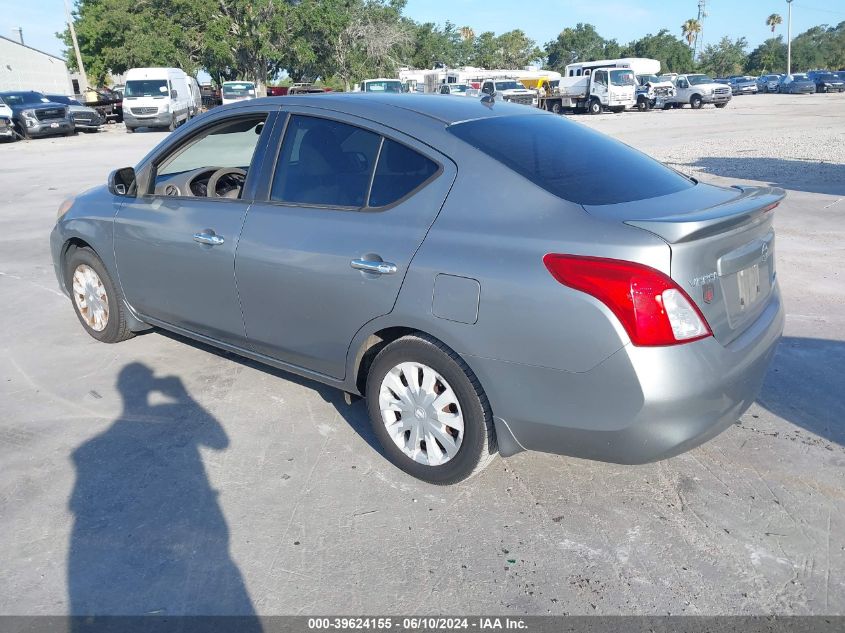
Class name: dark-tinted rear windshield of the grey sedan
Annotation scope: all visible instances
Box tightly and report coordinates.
[448,115,694,205]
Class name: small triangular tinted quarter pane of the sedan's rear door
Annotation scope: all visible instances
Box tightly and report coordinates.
[367,139,438,207]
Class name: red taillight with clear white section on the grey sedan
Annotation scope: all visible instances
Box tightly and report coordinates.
[543,253,711,346]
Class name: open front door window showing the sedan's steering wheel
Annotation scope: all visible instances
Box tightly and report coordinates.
[154,114,267,198]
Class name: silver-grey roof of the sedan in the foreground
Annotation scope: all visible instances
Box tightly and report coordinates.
[249,92,543,125]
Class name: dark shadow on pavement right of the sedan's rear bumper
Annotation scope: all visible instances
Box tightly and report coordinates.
[757,336,845,446]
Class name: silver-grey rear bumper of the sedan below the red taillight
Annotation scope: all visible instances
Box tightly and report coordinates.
[468,286,784,464]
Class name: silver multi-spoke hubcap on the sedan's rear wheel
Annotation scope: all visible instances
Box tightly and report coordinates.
[379,362,464,466]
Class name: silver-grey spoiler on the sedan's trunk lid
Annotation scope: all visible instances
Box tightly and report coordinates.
[625,185,786,244]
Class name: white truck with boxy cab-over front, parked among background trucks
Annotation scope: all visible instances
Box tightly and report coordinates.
[537,68,637,114]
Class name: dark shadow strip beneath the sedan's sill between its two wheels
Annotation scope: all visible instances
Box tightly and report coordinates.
[150,329,384,456]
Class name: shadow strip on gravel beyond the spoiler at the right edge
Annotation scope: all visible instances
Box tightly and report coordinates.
[668,156,845,196]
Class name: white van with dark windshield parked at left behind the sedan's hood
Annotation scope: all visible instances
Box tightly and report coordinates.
[123,68,194,132]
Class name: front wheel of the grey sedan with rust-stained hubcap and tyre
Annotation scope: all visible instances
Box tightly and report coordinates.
[65,248,133,343]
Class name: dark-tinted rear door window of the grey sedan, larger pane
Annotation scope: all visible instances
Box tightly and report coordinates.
[270,115,381,208]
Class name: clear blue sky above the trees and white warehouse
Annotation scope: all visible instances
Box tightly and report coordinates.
[0,0,845,61]
